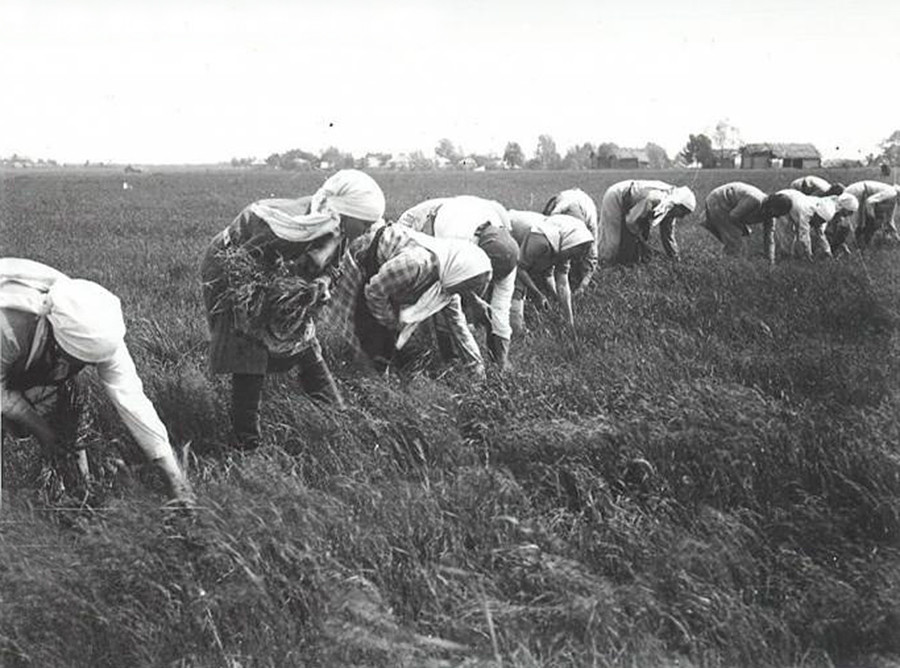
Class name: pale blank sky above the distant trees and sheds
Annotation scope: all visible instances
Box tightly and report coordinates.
[0,0,900,163]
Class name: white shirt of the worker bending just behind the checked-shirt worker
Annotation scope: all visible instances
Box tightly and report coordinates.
[397,195,516,340]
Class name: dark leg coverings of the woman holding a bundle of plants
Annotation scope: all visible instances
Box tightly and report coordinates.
[231,344,344,450]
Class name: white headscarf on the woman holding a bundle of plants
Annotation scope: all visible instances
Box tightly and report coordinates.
[250,169,385,242]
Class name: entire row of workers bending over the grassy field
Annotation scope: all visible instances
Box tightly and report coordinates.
[0,170,898,501]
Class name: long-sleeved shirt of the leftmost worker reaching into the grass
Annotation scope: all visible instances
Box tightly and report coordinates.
[0,308,177,468]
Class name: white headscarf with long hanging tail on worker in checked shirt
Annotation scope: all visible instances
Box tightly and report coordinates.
[396,231,491,350]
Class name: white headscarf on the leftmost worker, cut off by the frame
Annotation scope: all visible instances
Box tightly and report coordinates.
[0,258,125,368]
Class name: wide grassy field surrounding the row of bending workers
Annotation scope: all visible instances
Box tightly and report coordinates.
[0,170,900,667]
